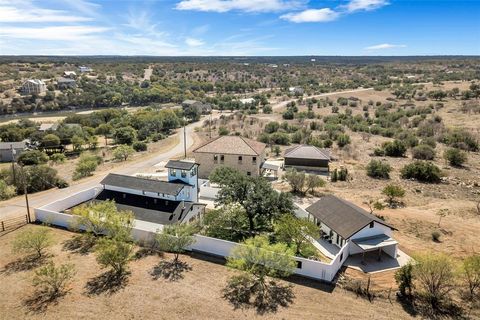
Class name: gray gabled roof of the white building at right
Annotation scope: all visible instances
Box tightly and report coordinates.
[305,195,393,239]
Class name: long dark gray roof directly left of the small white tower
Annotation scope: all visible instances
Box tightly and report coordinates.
[100,173,184,196]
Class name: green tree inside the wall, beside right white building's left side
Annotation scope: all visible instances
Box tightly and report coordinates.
[274,214,319,258]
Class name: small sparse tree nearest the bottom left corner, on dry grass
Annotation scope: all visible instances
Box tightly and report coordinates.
[33,262,76,299]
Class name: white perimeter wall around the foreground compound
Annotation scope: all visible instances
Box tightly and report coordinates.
[35,189,350,282]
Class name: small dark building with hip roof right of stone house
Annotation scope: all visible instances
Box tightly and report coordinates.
[284,145,330,172]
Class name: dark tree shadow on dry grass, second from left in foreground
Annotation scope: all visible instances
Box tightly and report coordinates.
[85,271,130,296]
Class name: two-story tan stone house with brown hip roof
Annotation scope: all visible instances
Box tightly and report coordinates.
[193,136,266,179]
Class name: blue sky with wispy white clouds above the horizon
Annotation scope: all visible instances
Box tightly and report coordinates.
[0,0,480,56]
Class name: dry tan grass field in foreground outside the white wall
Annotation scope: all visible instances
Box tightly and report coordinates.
[0,225,409,319]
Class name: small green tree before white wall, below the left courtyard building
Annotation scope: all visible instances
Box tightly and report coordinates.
[155,223,195,263]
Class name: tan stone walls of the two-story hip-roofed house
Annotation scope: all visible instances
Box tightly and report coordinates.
[194,152,265,179]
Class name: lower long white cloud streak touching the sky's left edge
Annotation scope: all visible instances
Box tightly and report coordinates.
[0,26,108,41]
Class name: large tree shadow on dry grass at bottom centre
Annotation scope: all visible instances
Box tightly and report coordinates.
[223,276,295,315]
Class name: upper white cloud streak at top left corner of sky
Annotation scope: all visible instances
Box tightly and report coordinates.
[0,6,92,23]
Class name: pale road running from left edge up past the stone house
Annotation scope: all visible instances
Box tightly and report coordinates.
[0,114,208,218]
